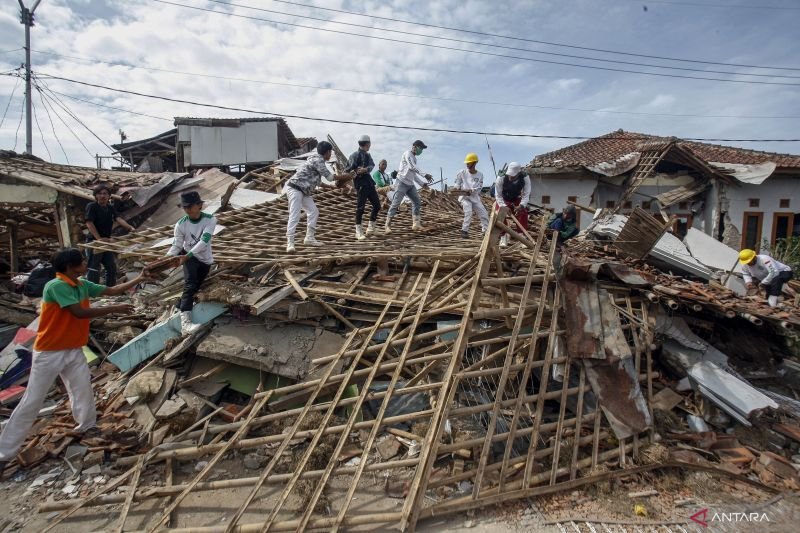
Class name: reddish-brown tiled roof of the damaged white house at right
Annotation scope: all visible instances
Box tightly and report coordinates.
[529,129,800,169]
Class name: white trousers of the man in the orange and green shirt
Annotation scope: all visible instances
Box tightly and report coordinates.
[0,348,97,461]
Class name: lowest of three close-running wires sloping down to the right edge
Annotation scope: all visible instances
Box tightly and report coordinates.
[151,0,800,87]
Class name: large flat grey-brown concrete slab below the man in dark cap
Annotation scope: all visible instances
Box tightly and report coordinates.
[197,319,345,379]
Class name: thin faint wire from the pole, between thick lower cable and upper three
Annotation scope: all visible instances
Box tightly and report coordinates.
[31,50,800,120]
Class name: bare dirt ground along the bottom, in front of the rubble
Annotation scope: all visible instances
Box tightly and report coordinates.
[0,456,800,533]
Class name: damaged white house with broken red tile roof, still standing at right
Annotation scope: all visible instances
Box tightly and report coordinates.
[528,130,800,245]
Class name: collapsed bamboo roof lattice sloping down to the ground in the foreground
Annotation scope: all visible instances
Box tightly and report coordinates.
[40,207,652,533]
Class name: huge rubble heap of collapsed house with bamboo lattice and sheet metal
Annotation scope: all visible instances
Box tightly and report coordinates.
[4,143,800,532]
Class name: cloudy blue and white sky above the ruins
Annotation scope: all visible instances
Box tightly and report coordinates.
[0,0,800,178]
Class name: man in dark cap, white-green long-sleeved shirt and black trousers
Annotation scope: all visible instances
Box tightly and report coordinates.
[167,191,217,335]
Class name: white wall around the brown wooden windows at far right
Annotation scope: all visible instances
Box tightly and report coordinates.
[723,176,800,249]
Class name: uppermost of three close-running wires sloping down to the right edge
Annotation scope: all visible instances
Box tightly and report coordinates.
[255,0,800,71]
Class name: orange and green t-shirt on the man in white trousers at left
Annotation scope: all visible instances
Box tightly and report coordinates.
[33,272,106,352]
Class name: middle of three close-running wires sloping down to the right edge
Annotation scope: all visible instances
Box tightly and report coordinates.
[202,0,800,79]
